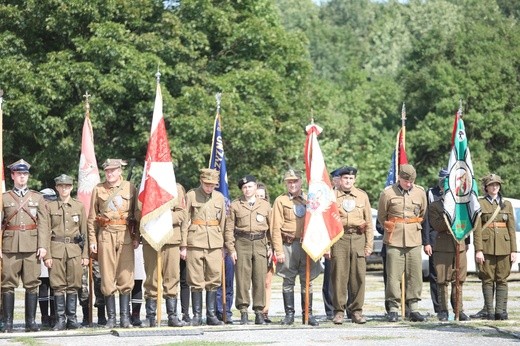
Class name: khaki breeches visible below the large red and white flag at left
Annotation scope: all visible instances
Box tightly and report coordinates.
[143,244,180,300]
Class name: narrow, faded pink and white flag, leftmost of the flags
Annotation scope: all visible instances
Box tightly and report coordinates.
[78,100,100,215]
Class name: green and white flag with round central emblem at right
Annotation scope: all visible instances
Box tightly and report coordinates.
[444,106,480,241]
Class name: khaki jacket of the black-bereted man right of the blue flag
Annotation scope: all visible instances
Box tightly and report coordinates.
[226,196,271,253]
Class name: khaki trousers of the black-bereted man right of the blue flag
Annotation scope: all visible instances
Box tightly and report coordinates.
[235,237,267,312]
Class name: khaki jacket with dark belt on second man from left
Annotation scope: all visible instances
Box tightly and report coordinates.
[45,198,88,260]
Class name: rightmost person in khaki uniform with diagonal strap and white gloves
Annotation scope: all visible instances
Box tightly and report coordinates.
[474,174,517,320]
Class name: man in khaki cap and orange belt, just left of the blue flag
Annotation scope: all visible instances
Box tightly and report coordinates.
[180,168,226,326]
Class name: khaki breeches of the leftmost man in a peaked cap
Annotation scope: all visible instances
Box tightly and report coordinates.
[2,252,41,293]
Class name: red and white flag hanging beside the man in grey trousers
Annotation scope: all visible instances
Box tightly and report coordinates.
[302,124,343,261]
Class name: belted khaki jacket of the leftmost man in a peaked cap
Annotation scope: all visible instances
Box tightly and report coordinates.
[1,190,50,253]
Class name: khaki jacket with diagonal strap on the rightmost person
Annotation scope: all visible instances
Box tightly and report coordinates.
[474,197,517,256]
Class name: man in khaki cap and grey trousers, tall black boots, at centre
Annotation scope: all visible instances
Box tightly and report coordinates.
[270,169,321,326]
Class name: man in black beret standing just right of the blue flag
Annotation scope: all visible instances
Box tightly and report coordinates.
[226,175,271,324]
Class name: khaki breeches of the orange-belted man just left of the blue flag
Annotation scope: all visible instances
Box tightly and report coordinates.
[186,247,223,292]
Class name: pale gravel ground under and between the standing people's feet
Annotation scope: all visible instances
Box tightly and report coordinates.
[0,266,520,346]
